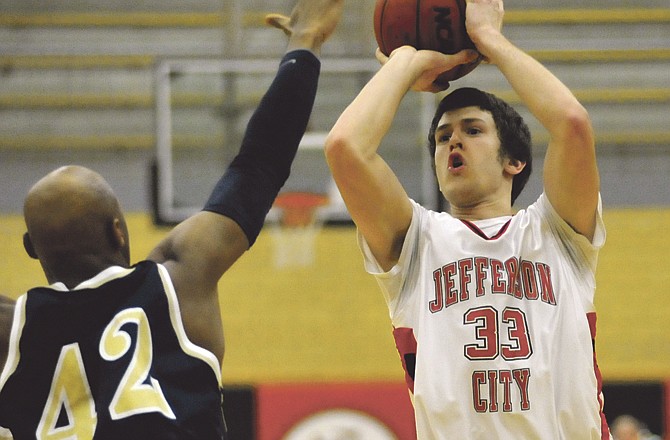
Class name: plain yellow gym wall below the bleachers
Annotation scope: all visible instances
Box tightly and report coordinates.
[0,209,670,384]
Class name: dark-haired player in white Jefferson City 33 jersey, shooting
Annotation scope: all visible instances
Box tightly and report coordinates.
[325,0,609,440]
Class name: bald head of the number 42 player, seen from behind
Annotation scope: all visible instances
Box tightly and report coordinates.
[23,166,129,281]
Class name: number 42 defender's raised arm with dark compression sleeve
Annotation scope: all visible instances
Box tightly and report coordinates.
[149,0,344,355]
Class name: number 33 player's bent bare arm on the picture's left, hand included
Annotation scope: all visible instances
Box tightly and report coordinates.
[325,46,476,269]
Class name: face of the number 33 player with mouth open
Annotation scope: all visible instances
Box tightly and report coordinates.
[435,107,509,207]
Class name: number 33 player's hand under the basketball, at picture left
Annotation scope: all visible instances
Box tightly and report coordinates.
[375,46,479,93]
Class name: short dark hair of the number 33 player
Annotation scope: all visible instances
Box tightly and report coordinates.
[428,87,533,204]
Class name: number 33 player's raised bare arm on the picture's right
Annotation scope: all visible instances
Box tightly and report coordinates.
[466,0,600,239]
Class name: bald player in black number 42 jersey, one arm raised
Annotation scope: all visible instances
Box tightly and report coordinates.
[0,0,343,440]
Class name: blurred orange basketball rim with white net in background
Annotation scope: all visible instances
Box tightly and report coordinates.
[272,192,328,268]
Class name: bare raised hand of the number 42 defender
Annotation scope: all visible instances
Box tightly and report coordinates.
[265,0,344,52]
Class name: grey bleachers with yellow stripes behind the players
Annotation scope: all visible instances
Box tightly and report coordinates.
[0,0,670,212]
